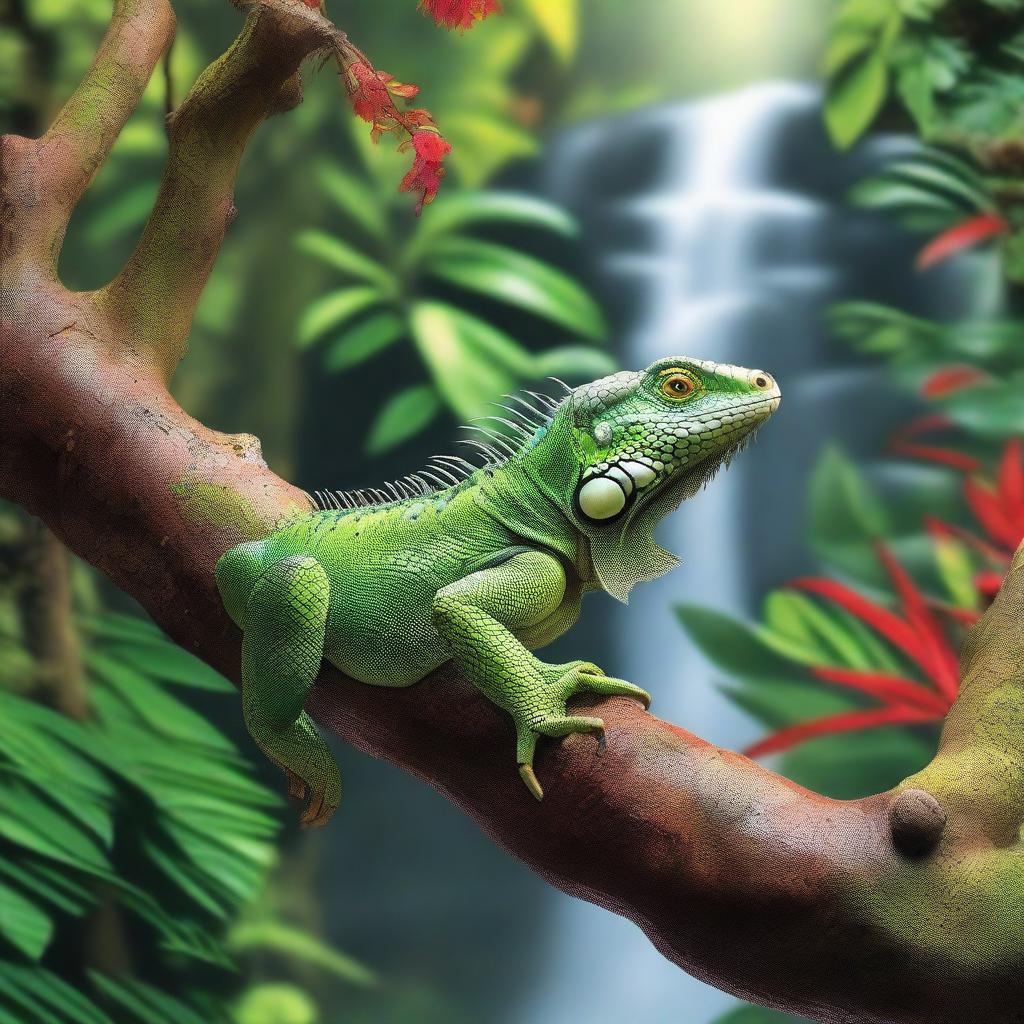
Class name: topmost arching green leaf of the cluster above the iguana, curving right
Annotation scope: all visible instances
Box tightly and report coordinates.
[404,190,580,261]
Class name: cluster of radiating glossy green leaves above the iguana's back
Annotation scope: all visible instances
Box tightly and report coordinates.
[296,173,613,454]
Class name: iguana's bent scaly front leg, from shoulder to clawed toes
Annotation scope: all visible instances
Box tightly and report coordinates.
[433,551,650,800]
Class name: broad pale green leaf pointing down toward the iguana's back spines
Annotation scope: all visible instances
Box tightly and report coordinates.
[410,302,530,420]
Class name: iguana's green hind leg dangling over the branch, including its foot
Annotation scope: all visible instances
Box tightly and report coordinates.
[242,556,341,825]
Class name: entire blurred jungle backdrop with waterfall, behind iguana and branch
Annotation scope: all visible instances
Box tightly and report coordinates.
[0,0,1024,1024]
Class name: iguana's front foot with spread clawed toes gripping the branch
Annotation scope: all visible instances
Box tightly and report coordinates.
[514,662,650,800]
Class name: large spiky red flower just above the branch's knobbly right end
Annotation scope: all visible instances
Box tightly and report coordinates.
[744,545,959,757]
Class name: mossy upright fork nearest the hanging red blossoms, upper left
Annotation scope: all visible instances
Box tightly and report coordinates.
[100,0,340,378]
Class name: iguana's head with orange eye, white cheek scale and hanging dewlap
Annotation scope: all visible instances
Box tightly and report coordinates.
[520,356,781,600]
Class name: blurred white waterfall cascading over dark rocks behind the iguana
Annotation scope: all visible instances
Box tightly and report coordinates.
[520,83,983,1024]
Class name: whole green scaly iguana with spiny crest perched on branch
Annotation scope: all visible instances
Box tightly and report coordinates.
[217,357,780,824]
